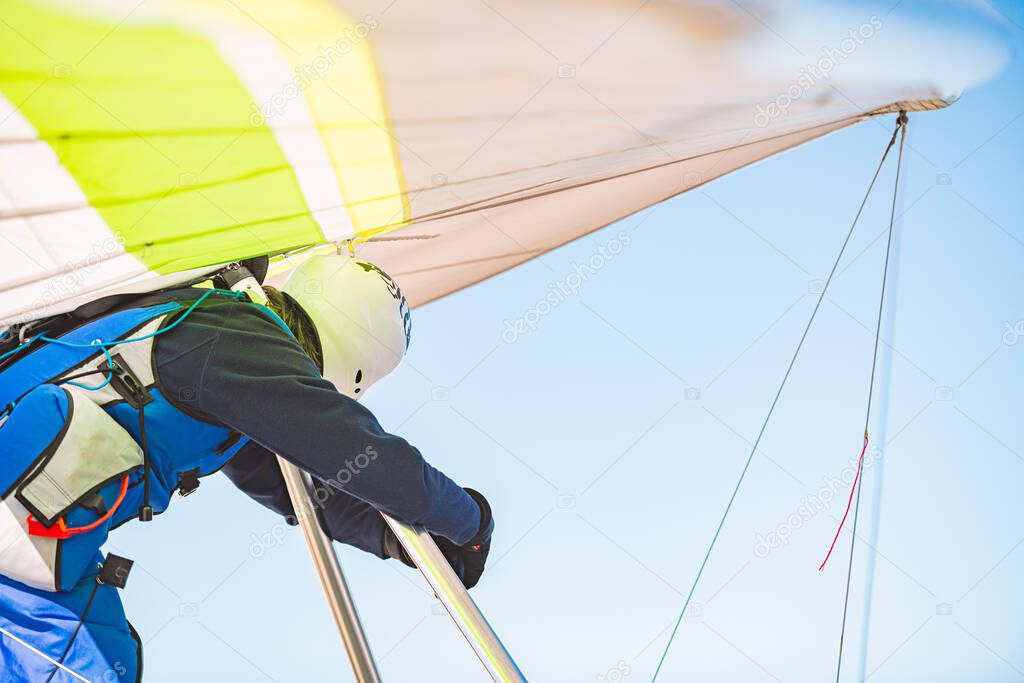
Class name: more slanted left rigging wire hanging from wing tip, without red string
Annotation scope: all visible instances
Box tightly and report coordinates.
[650,113,905,683]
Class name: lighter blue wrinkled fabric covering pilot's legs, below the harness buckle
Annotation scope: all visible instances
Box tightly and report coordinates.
[0,553,142,683]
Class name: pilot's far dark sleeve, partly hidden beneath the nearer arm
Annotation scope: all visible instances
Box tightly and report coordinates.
[221,442,389,557]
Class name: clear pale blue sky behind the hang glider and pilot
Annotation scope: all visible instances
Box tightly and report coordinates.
[110,2,1024,683]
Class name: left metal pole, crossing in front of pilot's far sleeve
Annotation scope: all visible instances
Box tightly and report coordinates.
[278,456,381,683]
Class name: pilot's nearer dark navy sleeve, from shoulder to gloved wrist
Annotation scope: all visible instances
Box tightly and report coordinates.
[155,302,480,544]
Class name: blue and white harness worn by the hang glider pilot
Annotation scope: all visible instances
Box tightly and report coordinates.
[0,290,270,683]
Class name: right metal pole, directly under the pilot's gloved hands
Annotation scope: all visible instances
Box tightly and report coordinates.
[384,515,526,683]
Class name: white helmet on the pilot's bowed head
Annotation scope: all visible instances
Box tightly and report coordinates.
[282,254,412,398]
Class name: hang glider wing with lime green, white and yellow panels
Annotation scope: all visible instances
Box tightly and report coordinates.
[0,0,995,323]
